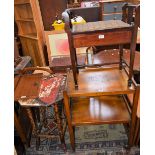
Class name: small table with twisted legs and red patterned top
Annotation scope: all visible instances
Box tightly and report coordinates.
[15,74,66,151]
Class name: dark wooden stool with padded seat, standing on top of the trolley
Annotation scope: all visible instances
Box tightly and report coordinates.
[64,18,137,86]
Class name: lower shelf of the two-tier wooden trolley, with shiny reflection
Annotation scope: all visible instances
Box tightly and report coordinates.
[71,96,130,126]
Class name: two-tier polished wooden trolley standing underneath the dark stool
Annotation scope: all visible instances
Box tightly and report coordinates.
[64,67,139,150]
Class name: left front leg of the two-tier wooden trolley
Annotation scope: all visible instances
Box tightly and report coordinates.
[64,91,75,151]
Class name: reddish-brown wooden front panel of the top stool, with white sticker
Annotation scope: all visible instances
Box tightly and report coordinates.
[73,30,132,48]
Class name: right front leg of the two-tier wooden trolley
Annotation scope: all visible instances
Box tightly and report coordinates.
[129,86,140,146]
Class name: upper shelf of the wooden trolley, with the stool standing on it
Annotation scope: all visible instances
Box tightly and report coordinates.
[67,68,135,97]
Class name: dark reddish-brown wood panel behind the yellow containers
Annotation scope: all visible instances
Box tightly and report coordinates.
[39,0,67,31]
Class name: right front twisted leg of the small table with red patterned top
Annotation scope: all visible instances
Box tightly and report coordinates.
[54,103,66,152]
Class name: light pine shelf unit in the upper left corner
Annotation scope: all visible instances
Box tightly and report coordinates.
[14,0,46,66]
